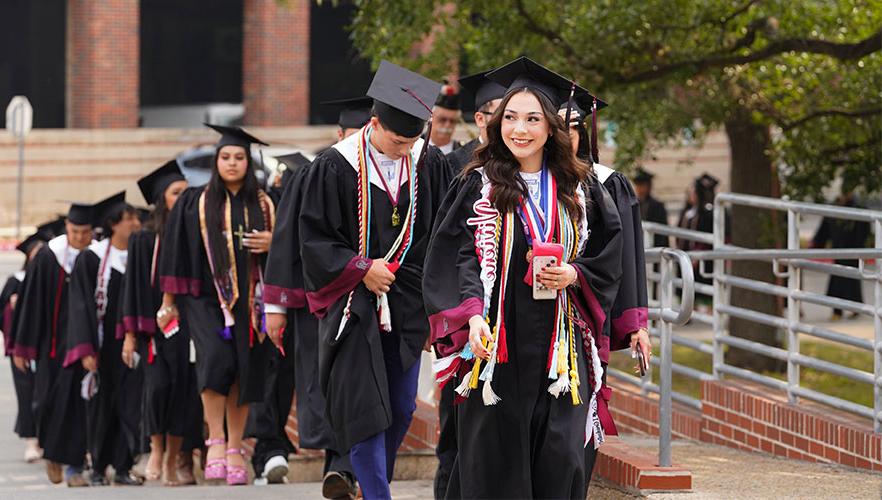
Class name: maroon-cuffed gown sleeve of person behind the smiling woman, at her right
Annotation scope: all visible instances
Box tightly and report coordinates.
[603,172,648,350]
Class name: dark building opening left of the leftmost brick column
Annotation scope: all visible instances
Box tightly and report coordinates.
[0,0,67,128]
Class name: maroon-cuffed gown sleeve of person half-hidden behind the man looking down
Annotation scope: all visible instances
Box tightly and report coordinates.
[263,165,309,309]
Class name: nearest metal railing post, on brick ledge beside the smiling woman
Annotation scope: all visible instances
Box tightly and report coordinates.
[658,252,674,467]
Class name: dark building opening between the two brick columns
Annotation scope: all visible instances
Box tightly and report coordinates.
[141,0,242,106]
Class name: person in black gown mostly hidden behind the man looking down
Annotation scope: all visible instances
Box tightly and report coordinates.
[249,97,373,492]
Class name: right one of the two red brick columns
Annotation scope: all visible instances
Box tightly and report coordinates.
[242,0,310,126]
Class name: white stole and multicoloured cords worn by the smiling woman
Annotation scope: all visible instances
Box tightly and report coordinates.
[454,168,582,405]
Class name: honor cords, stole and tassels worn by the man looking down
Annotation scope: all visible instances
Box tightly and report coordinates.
[335,126,425,340]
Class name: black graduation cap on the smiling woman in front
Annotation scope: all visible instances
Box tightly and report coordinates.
[486,56,588,108]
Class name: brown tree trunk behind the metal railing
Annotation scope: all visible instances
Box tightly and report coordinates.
[726,110,781,371]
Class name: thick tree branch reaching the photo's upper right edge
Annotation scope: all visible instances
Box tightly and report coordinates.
[613,29,882,84]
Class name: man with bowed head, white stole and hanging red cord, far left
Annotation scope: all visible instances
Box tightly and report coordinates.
[12,203,93,486]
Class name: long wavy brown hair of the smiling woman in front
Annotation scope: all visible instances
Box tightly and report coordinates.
[462,88,591,220]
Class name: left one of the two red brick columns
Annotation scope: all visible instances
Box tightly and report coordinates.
[67,0,141,128]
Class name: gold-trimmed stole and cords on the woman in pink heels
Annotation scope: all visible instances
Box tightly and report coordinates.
[199,186,275,346]
